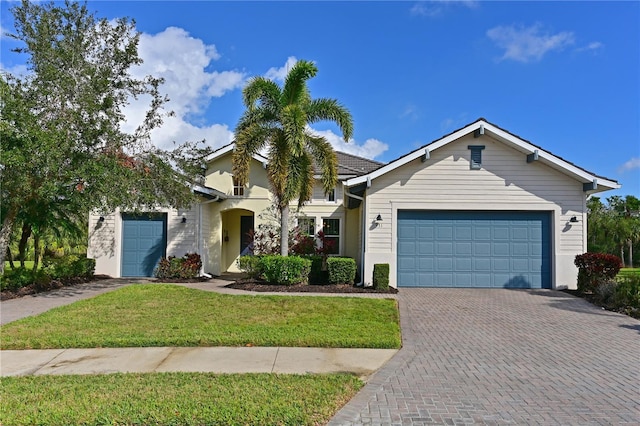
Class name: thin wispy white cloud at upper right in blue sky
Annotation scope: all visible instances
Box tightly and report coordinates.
[487,24,574,63]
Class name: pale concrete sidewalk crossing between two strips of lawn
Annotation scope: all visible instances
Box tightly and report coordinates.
[0,347,398,380]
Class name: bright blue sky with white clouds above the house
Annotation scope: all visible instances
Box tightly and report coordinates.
[0,1,640,197]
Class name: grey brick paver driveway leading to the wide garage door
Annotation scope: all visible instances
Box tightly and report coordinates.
[330,289,640,425]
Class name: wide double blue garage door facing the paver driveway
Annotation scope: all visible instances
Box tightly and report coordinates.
[398,210,551,288]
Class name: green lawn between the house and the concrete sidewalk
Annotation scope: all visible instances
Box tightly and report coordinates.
[0,284,400,349]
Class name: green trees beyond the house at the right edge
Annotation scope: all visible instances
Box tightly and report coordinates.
[587,195,640,268]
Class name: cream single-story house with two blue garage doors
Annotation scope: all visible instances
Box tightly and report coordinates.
[89,118,620,288]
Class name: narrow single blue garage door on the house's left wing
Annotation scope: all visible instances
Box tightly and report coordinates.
[122,213,167,277]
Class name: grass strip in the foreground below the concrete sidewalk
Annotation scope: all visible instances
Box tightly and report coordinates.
[0,373,363,425]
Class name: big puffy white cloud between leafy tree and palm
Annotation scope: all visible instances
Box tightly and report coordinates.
[123,27,246,148]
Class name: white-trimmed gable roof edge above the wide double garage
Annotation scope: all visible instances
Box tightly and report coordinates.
[345,118,620,193]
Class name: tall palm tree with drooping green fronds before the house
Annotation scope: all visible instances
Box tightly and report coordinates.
[233,60,353,256]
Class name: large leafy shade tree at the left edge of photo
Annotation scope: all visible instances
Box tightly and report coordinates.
[0,1,209,273]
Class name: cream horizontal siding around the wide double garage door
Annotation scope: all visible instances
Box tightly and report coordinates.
[366,135,585,285]
